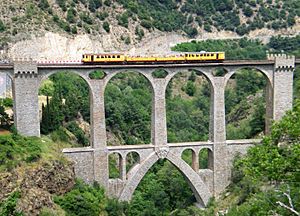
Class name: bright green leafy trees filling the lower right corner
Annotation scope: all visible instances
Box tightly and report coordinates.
[204,100,300,216]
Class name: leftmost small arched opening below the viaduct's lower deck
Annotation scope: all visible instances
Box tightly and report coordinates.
[108,152,123,179]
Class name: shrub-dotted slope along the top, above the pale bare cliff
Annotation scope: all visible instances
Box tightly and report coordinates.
[0,0,300,47]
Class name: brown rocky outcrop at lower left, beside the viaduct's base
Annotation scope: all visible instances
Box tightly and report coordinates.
[0,161,75,216]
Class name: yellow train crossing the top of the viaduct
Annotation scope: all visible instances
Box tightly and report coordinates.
[82,52,225,64]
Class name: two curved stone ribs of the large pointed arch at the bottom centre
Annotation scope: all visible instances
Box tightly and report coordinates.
[119,152,212,207]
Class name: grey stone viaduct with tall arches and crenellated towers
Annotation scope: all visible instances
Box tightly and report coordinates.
[0,54,295,206]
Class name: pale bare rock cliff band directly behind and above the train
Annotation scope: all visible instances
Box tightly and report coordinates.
[8,19,300,61]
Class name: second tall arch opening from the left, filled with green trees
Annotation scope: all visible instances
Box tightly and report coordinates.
[103,69,154,145]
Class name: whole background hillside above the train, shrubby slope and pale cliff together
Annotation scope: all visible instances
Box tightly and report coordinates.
[0,0,300,59]
